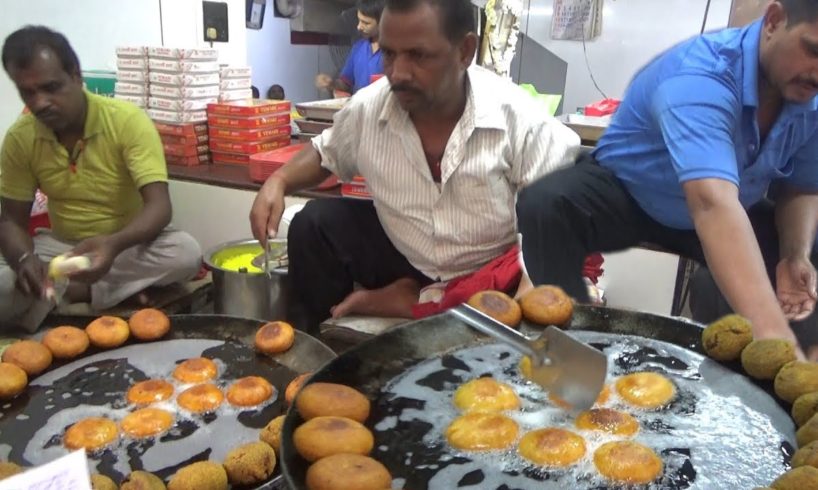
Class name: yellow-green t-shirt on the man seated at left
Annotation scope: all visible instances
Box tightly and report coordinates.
[0,92,168,241]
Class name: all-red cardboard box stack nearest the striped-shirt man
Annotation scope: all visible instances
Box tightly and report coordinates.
[207,99,292,165]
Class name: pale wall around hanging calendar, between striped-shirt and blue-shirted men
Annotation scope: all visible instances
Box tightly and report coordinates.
[521,0,731,112]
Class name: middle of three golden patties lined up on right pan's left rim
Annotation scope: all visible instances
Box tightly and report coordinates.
[293,417,375,461]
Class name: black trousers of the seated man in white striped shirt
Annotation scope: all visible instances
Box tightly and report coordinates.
[287,199,431,332]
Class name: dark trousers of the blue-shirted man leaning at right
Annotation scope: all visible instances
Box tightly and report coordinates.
[517,154,816,345]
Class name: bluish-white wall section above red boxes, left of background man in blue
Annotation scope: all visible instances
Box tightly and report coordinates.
[247,5,335,102]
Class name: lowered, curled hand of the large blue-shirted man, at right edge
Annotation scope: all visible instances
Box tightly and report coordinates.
[775,258,818,320]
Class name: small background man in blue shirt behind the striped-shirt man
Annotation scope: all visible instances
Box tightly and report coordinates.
[316,0,383,94]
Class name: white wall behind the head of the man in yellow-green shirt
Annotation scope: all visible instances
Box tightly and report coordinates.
[0,0,247,139]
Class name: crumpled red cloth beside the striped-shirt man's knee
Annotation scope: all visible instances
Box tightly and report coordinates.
[412,245,603,318]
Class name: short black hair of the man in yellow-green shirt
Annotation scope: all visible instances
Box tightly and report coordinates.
[3,26,81,75]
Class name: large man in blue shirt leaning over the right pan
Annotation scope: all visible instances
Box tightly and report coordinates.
[517,0,818,358]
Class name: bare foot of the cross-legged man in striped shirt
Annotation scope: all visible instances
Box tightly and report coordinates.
[330,278,420,318]
